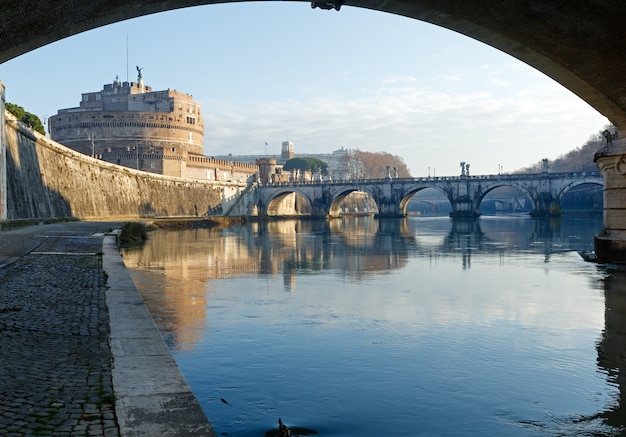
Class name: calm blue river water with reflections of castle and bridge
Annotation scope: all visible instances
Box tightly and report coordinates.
[118,216,626,437]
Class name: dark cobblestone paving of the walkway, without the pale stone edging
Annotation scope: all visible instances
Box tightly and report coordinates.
[0,229,119,437]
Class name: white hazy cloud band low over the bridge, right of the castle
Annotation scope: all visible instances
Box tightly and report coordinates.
[205,78,602,175]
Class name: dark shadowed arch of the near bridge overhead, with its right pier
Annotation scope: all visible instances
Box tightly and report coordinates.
[0,0,626,263]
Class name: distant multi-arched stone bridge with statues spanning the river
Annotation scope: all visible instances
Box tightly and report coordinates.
[251,172,603,217]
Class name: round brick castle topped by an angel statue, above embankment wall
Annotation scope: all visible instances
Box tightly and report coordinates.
[48,76,258,181]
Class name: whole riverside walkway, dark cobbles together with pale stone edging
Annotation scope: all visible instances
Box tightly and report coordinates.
[0,222,215,437]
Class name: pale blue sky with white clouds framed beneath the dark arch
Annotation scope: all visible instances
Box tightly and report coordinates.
[0,1,609,176]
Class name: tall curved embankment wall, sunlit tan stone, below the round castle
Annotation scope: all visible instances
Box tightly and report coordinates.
[0,111,233,220]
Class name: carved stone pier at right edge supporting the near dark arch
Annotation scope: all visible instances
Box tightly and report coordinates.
[594,138,626,263]
